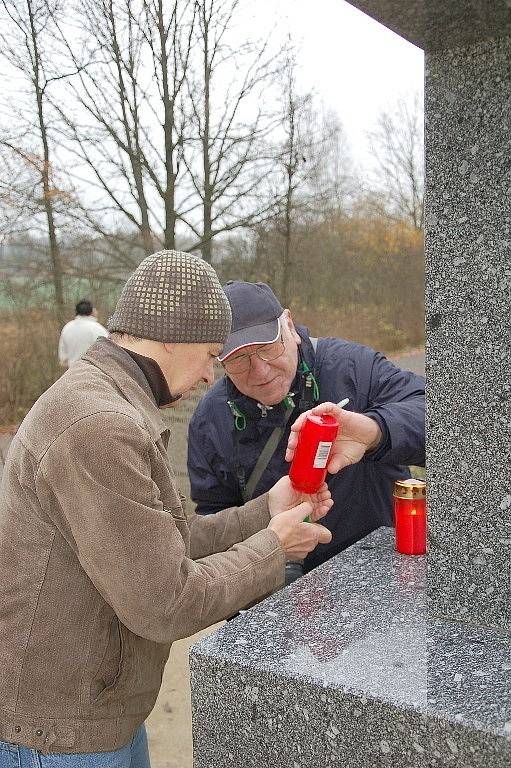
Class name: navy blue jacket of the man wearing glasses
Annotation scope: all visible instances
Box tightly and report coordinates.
[188,327,424,570]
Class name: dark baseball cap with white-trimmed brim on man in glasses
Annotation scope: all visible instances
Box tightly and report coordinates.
[218,280,284,362]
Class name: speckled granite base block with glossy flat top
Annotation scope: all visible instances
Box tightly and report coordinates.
[191,528,511,768]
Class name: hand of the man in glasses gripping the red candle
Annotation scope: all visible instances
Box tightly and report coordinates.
[286,403,382,475]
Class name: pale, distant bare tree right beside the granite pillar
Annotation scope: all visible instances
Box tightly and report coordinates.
[369,95,424,229]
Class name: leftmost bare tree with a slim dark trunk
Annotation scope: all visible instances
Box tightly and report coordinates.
[0,0,74,323]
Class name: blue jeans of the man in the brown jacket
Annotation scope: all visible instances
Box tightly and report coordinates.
[0,725,151,768]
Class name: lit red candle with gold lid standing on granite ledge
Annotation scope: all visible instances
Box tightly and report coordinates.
[394,478,426,555]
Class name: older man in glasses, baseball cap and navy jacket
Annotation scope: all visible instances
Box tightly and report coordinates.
[188,281,425,582]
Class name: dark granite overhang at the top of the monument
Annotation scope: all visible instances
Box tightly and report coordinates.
[348,0,511,50]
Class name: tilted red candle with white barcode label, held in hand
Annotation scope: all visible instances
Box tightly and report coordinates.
[289,413,339,493]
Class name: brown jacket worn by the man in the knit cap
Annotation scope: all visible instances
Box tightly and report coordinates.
[0,339,285,753]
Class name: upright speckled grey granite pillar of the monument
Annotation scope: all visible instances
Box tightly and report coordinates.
[426,37,511,630]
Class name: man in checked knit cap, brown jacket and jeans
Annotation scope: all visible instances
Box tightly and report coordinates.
[0,251,331,768]
